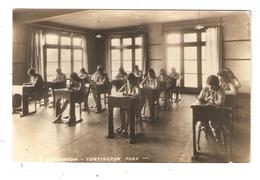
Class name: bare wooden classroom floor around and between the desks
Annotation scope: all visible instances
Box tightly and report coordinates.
[13,95,250,163]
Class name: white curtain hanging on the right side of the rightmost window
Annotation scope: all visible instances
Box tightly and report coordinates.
[206,26,222,76]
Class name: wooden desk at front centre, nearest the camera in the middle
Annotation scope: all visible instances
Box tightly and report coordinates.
[107,95,139,144]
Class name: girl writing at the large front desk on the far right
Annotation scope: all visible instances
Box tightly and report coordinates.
[197,75,225,141]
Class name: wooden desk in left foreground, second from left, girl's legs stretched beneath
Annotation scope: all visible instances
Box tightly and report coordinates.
[54,88,83,126]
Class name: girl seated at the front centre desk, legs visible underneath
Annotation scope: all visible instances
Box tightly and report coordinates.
[116,73,144,136]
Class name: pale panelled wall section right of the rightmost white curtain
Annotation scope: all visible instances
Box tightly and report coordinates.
[222,14,251,93]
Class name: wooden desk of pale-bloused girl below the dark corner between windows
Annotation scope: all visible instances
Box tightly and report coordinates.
[90,83,111,112]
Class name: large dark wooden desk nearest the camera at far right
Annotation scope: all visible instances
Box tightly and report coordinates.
[191,104,232,159]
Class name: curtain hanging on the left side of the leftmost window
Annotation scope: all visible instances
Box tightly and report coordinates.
[27,28,44,77]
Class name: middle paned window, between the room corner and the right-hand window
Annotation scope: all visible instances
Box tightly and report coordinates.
[110,35,144,78]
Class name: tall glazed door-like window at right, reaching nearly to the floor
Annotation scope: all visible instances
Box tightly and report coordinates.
[166,29,206,89]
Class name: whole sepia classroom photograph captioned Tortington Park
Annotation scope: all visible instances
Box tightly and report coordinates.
[12,8,251,163]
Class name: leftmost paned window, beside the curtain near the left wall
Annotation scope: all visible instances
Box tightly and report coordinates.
[44,33,83,81]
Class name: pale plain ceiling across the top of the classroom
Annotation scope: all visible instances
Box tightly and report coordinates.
[13,9,247,30]
